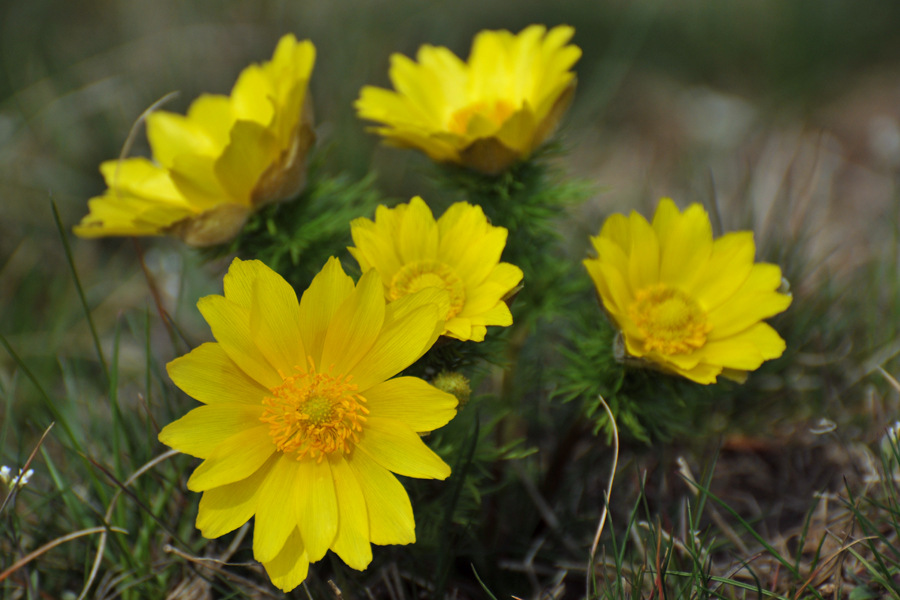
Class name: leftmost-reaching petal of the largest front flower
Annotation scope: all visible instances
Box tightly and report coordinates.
[159,402,263,458]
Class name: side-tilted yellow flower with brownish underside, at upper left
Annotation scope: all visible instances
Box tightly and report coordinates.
[75,34,316,246]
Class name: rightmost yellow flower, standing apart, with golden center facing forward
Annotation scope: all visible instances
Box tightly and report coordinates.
[584,198,791,383]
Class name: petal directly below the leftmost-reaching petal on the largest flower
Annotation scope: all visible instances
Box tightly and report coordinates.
[188,425,275,492]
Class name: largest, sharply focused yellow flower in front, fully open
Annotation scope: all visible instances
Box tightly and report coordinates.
[159,258,457,591]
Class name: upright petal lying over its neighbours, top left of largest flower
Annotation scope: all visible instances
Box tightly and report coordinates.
[250,261,308,376]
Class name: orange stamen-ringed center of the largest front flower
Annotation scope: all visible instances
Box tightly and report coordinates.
[259,359,369,462]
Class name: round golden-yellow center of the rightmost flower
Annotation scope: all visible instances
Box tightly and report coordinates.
[628,283,712,355]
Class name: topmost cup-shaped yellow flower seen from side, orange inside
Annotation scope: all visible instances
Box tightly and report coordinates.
[356,25,581,174]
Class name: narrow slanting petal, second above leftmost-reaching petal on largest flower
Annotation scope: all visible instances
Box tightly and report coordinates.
[197,296,282,389]
